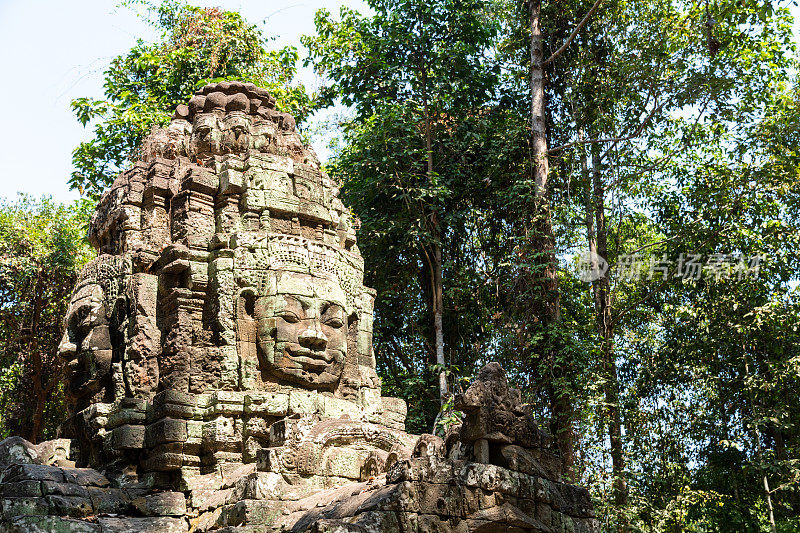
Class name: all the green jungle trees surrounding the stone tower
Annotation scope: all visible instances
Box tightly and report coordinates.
[0,0,800,532]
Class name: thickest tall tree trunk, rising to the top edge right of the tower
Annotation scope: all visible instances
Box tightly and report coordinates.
[528,0,575,477]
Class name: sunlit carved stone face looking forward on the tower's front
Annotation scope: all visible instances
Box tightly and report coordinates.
[255,273,347,389]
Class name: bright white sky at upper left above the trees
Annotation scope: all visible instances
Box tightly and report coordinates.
[0,0,367,201]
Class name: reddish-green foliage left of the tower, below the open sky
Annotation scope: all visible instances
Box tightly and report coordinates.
[0,196,93,442]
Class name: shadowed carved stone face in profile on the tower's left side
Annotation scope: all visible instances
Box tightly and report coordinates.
[58,283,112,400]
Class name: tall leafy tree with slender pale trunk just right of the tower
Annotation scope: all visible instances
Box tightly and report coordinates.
[303,0,495,412]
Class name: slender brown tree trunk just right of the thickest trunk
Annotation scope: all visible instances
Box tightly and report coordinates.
[592,145,628,505]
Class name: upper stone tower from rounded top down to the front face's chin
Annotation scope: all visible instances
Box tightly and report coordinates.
[70,82,379,407]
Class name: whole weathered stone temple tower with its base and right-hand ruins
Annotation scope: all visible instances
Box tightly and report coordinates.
[0,82,596,532]
